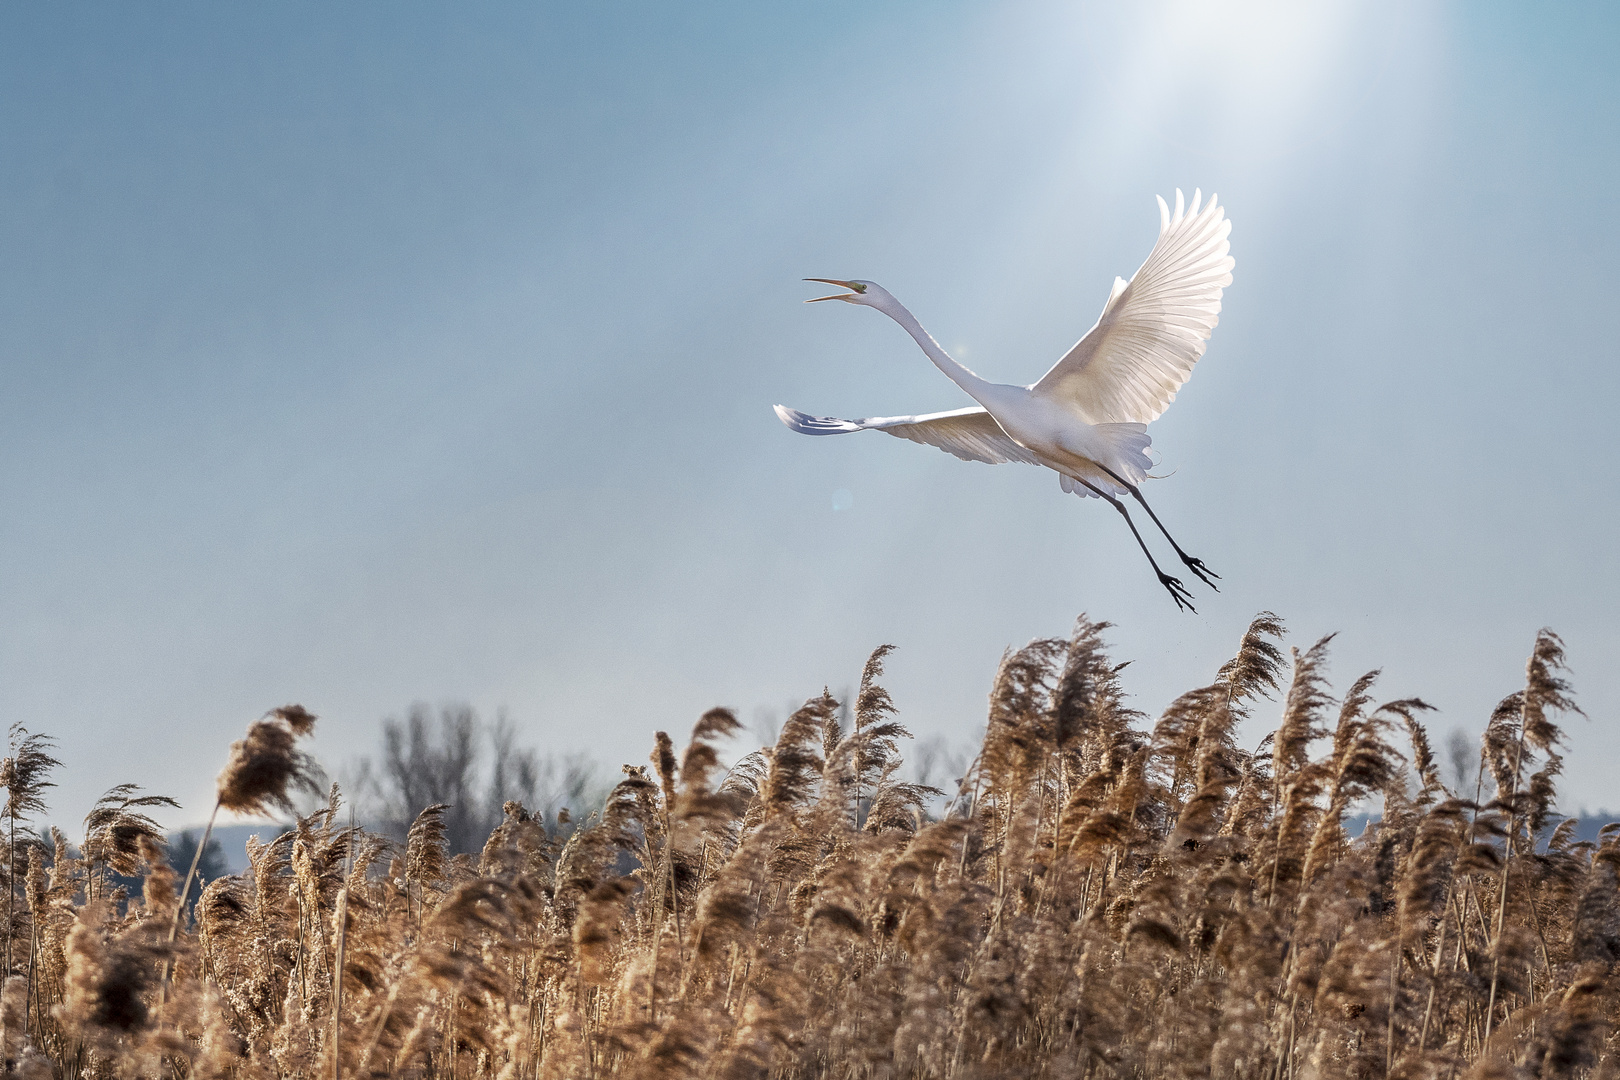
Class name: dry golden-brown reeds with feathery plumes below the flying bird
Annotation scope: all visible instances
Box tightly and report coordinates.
[0,615,1620,1080]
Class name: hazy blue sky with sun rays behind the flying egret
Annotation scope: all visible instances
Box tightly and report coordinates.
[0,0,1620,824]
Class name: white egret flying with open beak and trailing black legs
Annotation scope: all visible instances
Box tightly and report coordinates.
[776,189,1233,610]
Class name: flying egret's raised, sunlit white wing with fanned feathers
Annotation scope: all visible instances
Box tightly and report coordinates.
[1030,189,1233,424]
